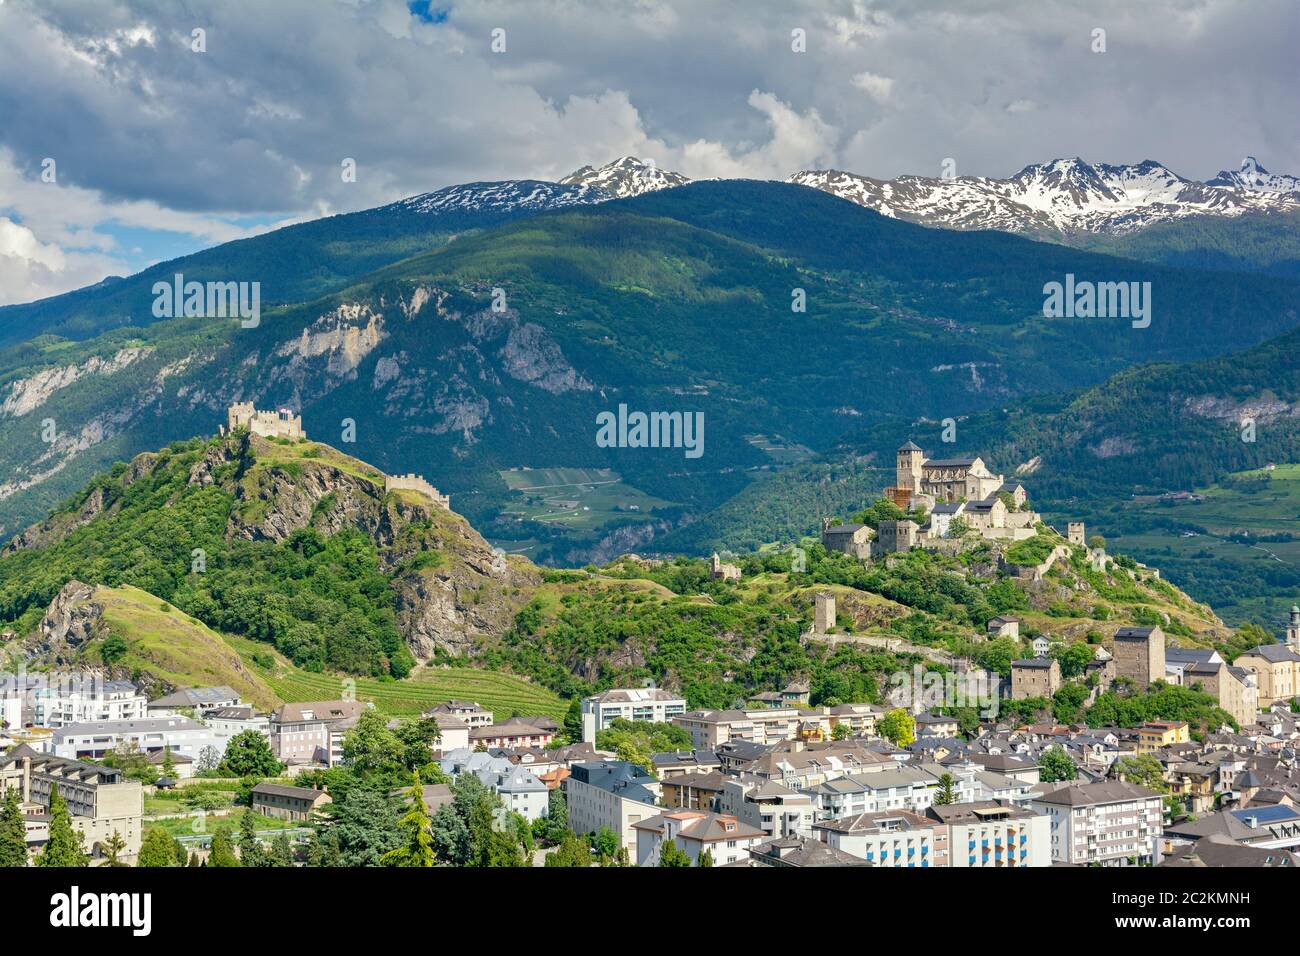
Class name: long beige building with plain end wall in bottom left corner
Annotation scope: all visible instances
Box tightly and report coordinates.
[0,744,144,864]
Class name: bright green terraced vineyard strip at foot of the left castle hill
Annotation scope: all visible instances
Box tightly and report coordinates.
[226,636,567,721]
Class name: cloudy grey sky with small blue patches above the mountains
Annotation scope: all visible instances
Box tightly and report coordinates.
[0,0,1300,304]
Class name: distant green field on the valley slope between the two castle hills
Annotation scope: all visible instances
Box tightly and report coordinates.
[498,468,673,541]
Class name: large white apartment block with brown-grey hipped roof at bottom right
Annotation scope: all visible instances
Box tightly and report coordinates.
[1031,780,1165,866]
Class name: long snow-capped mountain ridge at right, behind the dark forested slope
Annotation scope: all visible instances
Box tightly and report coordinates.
[789,157,1300,234]
